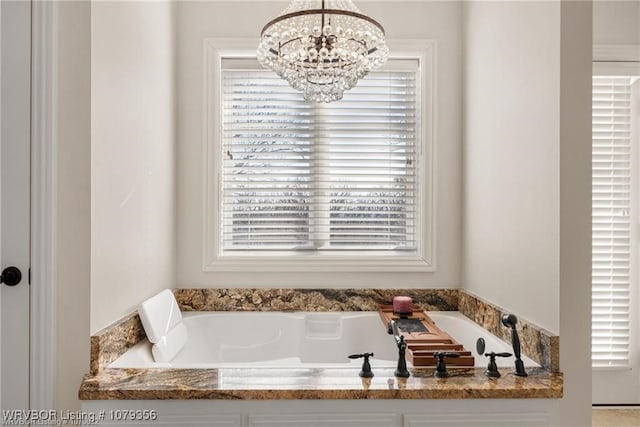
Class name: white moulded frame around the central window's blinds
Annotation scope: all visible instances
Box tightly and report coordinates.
[202,38,436,272]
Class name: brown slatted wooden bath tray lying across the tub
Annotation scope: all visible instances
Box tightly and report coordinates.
[378,305,475,366]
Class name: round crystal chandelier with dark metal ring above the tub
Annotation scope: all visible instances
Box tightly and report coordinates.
[257,0,389,102]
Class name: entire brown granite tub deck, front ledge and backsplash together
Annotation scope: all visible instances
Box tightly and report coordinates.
[79,289,563,401]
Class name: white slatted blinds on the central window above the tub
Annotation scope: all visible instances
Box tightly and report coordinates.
[220,60,419,253]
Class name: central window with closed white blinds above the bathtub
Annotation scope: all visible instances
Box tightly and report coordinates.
[205,41,433,271]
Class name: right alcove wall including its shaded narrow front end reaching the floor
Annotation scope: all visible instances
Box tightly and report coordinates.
[463,1,592,426]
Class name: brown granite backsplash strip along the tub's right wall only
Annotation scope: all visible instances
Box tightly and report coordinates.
[458,291,560,372]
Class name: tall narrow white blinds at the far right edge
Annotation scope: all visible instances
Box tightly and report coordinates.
[591,77,631,367]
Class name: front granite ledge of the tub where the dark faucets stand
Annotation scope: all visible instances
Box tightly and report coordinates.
[79,366,562,400]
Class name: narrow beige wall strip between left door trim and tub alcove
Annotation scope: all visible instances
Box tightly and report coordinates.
[55,2,91,410]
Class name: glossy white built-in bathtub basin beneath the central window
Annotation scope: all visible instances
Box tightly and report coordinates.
[109,312,538,369]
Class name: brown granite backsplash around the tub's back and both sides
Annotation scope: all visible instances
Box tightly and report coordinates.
[90,288,559,375]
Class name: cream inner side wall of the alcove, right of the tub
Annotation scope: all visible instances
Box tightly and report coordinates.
[464,2,560,332]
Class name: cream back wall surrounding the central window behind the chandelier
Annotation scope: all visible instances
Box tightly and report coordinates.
[177,1,462,287]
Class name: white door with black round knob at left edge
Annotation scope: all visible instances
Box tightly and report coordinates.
[0,0,31,411]
